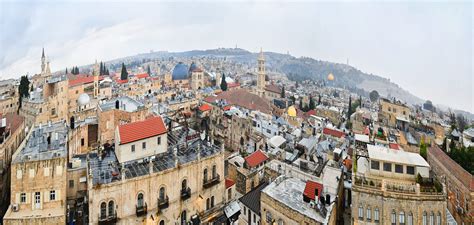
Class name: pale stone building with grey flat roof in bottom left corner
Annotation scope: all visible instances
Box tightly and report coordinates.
[3,121,67,225]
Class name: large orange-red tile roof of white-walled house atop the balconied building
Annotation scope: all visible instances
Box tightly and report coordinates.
[119,116,167,144]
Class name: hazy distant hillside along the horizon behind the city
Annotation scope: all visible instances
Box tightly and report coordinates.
[111,48,423,104]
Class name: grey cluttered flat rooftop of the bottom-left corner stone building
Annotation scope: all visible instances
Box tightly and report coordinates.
[13,121,68,163]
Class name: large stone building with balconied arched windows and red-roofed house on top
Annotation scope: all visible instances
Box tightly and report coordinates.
[88,118,226,224]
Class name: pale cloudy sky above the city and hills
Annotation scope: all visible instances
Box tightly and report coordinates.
[0,0,474,113]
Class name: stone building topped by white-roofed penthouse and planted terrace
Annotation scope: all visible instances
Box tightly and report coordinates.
[351,145,446,225]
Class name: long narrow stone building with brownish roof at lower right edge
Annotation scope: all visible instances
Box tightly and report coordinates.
[428,145,474,224]
